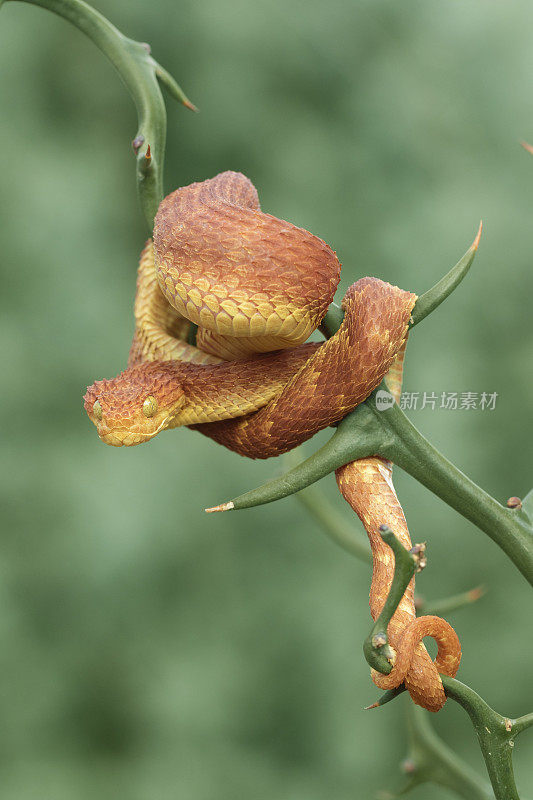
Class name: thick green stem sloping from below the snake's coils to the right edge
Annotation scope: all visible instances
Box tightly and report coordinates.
[374,398,533,585]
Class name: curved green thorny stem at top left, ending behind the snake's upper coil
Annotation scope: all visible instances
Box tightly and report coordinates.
[4,0,194,230]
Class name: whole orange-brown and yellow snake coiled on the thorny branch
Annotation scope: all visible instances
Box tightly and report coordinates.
[84,171,461,711]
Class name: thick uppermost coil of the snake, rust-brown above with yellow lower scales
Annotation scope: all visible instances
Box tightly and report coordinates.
[154,172,340,354]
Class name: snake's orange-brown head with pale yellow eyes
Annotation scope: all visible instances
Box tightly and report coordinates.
[83,361,185,447]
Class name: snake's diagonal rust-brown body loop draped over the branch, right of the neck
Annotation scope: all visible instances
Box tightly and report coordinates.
[191,278,416,458]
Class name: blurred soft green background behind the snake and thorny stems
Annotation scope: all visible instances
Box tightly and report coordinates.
[0,0,533,800]
